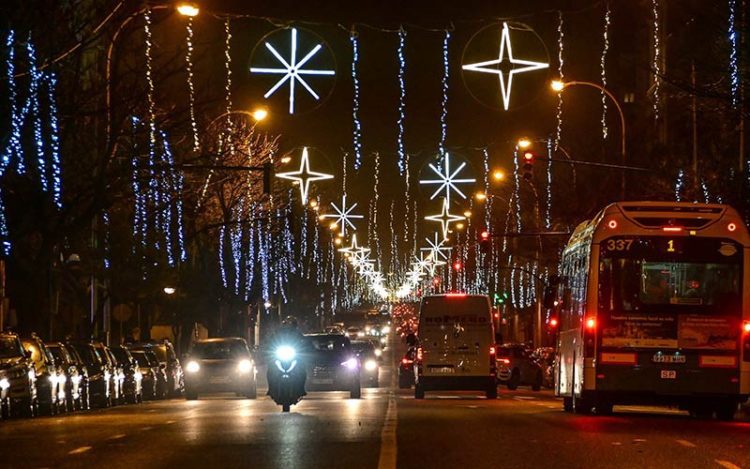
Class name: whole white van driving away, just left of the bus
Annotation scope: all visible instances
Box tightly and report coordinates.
[414,293,497,399]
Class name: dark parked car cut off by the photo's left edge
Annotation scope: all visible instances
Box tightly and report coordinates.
[0,333,37,418]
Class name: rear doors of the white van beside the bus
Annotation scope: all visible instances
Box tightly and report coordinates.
[419,295,493,377]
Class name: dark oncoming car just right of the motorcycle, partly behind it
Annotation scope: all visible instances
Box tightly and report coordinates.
[305,334,361,399]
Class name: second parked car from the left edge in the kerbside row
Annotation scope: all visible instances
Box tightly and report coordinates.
[21,334,67,415]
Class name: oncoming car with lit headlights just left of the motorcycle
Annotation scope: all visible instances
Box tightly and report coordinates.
[185,337,258,400]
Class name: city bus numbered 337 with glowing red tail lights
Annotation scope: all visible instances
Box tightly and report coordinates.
[555,202,750,420]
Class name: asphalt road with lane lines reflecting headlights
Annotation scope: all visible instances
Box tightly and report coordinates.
[0,340,750,469]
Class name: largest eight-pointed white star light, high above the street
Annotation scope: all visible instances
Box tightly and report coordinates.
[250,28,336,114]
